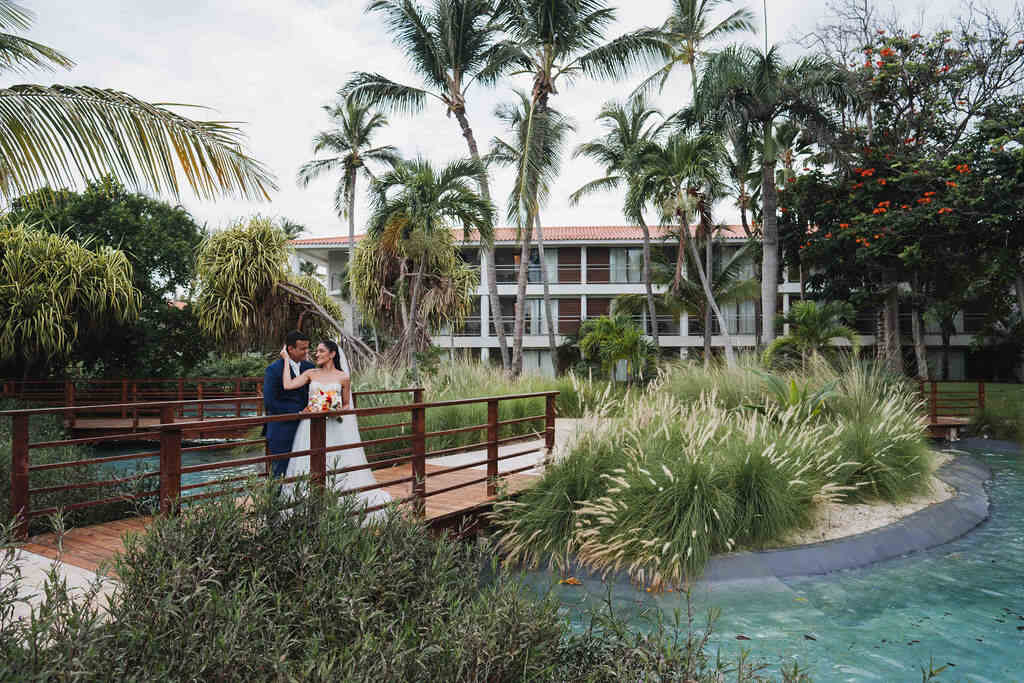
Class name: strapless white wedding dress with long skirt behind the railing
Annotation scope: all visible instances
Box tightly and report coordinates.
[282,380,391,518]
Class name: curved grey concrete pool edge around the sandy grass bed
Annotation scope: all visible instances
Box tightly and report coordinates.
[548,448,1003,586]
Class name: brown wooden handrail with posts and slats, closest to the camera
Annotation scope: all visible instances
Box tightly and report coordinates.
[0,387,558,539]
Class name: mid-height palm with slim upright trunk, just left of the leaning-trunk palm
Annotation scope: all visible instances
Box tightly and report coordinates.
[569,95,664,345]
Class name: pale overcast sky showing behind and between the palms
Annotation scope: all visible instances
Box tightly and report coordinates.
[17,0,1013,236]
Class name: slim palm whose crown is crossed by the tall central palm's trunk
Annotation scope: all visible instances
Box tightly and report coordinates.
[487,90,575,359]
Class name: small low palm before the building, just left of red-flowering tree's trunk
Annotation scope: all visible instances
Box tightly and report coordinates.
[764,301,859,369]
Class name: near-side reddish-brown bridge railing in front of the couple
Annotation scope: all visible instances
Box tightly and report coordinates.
[0,388,558,539]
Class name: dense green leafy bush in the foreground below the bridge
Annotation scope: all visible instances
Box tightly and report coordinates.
[0,487,802,682]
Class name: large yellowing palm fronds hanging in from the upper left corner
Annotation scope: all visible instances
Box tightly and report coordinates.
[0,0,276,200]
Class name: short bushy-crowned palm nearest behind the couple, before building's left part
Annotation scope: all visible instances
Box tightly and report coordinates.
[368,159,495,368]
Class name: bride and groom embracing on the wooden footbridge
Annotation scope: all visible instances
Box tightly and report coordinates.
[263,332,391,514]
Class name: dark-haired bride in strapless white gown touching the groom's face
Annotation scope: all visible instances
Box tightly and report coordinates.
[281,340,391,518]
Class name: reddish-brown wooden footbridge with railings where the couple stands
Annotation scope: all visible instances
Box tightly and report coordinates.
[0,387,558,569]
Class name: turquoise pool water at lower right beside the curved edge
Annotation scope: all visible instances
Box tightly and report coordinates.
[528,452,1024,682]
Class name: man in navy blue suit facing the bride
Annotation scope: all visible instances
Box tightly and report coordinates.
[263,331,313,477]
